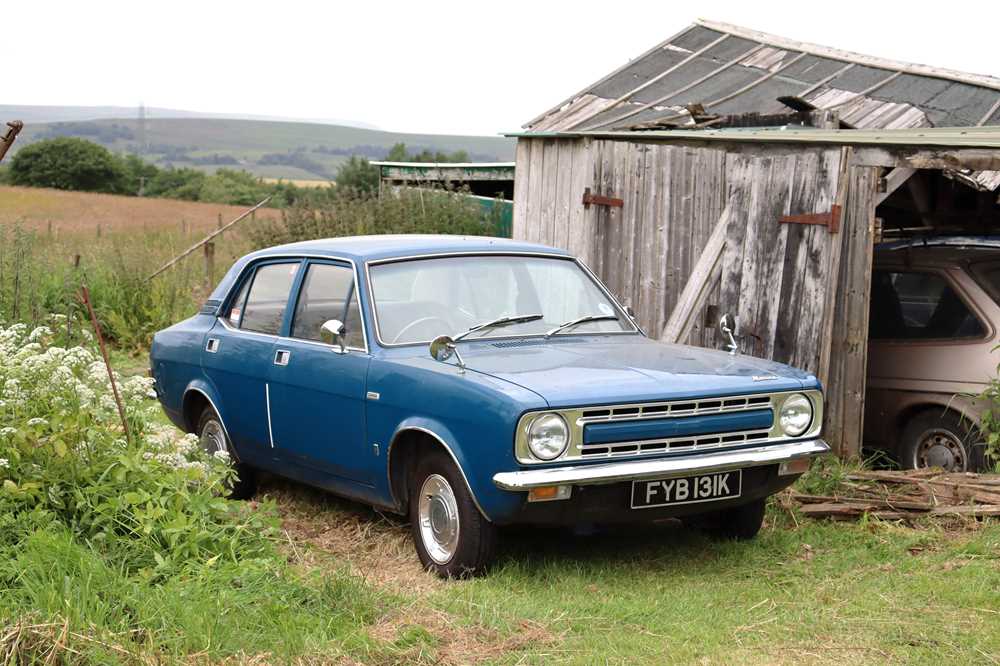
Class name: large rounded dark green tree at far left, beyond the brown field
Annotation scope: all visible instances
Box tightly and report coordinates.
[10,137,125,193]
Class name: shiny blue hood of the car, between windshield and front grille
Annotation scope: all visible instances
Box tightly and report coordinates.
[459,335,819,408]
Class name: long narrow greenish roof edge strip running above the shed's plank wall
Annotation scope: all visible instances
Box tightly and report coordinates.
[507,126,1000,150]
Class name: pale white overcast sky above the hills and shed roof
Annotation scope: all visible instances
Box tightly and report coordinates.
[9,0,1000,134]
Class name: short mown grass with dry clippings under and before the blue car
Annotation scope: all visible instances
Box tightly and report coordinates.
[263,474,1000,664]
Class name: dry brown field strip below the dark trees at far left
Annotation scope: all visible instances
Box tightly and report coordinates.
[0,186,281,235]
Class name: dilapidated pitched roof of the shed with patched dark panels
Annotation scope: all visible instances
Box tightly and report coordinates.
[525,20,1000,132]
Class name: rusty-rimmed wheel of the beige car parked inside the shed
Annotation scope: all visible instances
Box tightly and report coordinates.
[897,409,990,472]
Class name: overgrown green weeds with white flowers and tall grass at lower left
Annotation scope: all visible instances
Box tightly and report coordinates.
[0,319,377,664]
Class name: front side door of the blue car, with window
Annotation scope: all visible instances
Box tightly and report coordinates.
[268,259,372,483]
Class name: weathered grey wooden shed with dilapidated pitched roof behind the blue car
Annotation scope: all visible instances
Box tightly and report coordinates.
[513,23,1000,455]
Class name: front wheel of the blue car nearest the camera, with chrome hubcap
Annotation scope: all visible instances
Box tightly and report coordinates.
[409,450,497,578]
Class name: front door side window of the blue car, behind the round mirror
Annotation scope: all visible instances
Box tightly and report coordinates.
[292,264,365,349]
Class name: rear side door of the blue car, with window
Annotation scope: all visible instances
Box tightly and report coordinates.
[202,259,302,460]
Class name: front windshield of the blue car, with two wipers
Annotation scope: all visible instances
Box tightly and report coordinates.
[370,255,636,344]
